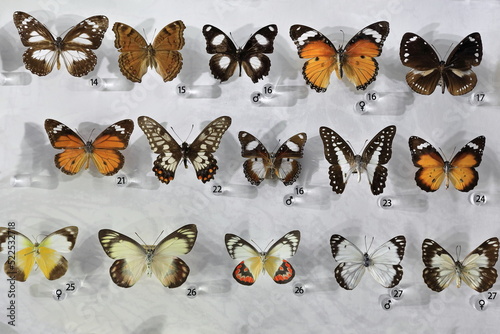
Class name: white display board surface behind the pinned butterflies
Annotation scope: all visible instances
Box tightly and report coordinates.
[0,0,500,333]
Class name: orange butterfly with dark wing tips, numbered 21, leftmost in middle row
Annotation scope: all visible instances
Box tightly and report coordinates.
[45,119,134,175]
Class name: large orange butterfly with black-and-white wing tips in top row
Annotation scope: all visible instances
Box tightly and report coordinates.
[290,21,389,92]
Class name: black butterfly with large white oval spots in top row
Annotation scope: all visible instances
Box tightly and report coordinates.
[203,24,278,83]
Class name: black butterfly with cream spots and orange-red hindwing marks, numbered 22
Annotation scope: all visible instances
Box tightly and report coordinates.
[137,116,231,184]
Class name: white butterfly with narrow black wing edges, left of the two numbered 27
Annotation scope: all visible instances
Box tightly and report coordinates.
[330,234,406,290]
